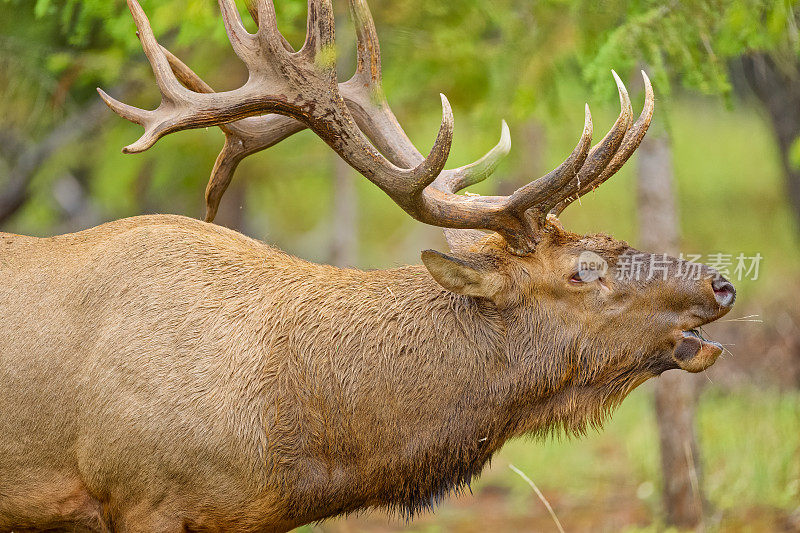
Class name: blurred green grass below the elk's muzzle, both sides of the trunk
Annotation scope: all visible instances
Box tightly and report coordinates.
[476,388,800,519]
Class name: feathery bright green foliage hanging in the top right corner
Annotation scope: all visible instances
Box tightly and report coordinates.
[573,0,800,101]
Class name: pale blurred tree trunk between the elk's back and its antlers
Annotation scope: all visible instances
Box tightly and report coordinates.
[329,156,358,267]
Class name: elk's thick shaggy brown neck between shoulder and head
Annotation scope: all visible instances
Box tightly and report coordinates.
[244,254,612,516]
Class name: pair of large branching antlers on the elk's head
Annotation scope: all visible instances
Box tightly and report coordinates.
[98,0,653,254]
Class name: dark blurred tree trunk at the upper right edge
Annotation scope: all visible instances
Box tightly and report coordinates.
[741,53,800,228]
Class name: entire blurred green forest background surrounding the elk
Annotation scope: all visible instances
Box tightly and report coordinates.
[0,0,800,532]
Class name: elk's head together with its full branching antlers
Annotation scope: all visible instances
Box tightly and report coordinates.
[100,0,735,424]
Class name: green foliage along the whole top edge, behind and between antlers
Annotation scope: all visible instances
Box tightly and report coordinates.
[9,0,800,135]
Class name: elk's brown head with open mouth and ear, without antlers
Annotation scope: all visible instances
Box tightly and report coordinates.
[422,225,735,433]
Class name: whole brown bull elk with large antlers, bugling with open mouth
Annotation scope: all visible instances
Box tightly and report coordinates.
[0,0,735,533]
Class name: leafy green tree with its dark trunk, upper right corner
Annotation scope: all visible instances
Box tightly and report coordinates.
[571,0,800,227]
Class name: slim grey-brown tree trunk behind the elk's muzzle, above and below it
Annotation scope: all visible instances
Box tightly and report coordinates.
[637,132,703,528]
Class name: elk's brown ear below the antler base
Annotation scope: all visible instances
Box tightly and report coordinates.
[422,250,503,300]
